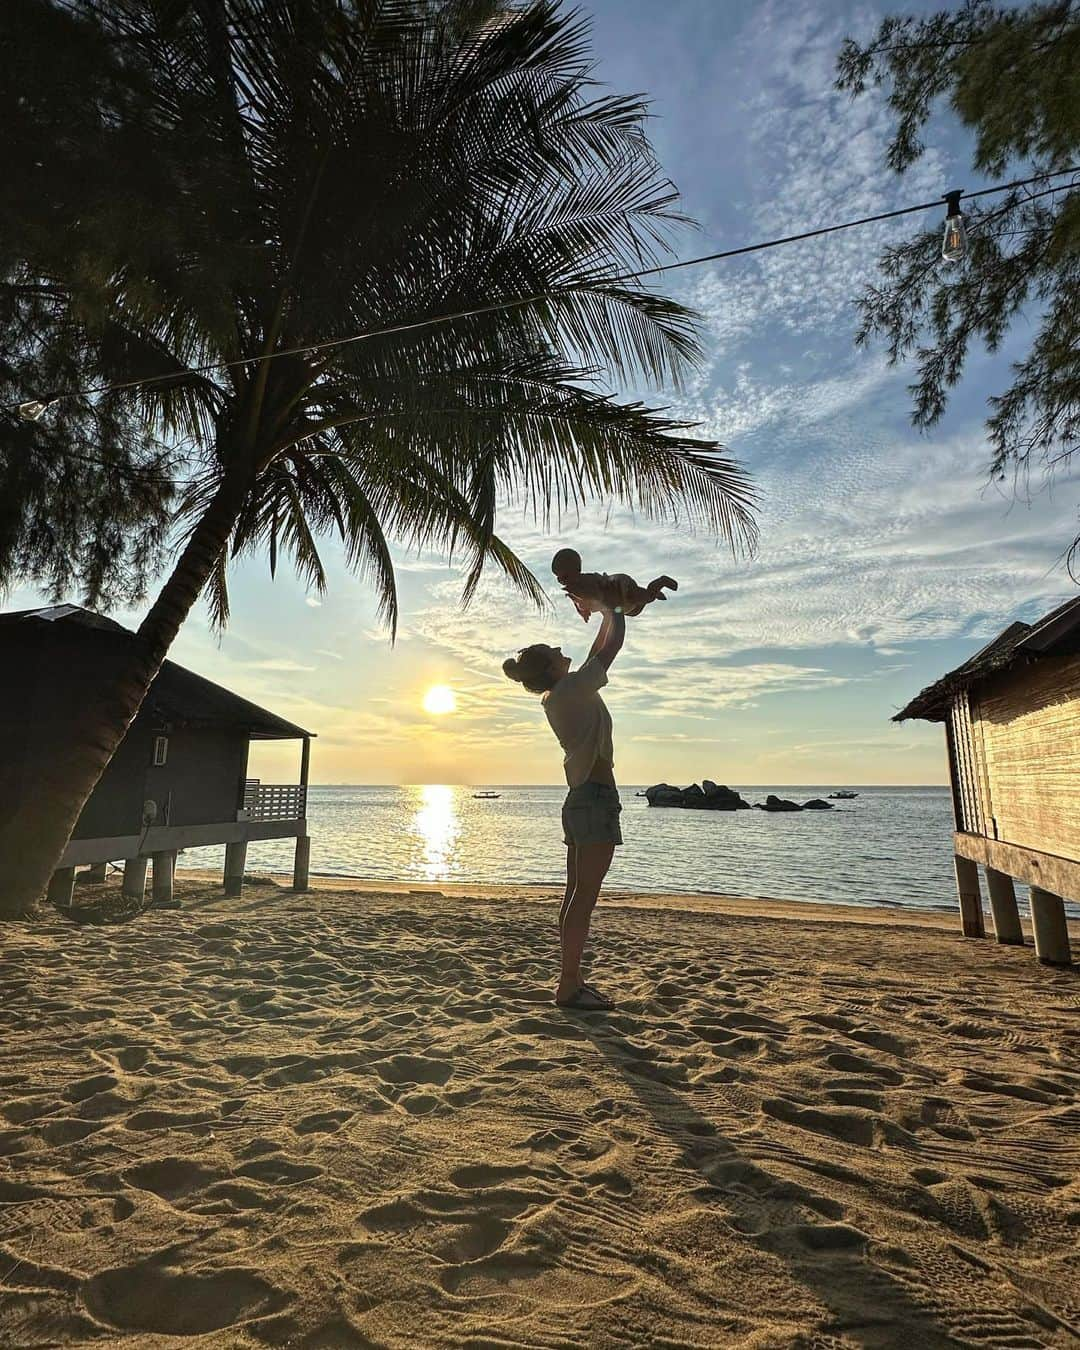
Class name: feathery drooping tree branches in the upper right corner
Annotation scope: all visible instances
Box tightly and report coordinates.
[837,0,1080,570]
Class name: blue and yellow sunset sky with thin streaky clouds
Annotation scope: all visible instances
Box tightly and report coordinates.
[8,0,1080,786]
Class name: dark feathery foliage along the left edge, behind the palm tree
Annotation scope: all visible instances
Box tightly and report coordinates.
[0,0,176,605]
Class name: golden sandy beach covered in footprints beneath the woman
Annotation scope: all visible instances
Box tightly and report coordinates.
[0,878,1080,1350]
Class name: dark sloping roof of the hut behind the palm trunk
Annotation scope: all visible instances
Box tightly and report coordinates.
[0,605,315,741]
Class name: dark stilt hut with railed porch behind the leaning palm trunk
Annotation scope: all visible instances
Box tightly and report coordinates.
[0,605,312,909]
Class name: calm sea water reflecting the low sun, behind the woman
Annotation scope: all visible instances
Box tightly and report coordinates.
[181,783,972,910]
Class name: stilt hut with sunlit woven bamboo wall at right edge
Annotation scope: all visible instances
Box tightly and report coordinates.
[894,598,1080,965]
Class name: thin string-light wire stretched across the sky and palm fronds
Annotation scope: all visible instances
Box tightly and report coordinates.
[0,165,1080,412]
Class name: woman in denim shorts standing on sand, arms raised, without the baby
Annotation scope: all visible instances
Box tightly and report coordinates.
[502,610,626,1011]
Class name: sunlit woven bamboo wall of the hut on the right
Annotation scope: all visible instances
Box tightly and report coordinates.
[971,656,1080,861]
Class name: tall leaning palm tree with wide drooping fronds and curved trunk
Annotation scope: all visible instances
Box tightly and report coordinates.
[0,0,753,910]
